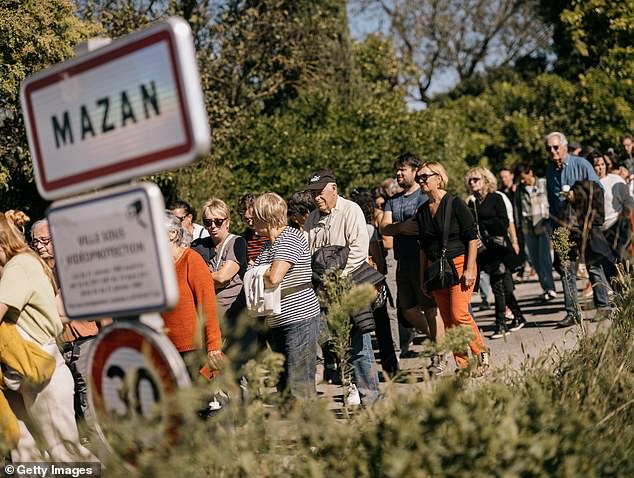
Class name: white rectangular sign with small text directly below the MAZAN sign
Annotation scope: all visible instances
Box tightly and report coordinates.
[47,183,178,319]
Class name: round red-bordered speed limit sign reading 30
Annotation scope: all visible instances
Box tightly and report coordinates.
[88,321,191,461]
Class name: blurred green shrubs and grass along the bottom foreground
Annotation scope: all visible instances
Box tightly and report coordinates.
[82,270,634,478]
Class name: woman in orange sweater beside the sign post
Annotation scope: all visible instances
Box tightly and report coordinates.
[161,212,224,378]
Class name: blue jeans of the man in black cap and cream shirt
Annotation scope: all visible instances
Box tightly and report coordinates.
[350,327,379,405]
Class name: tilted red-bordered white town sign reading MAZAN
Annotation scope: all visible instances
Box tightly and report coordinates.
[21,18,210,199]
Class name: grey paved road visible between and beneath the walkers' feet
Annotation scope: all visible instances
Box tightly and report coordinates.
[317,270,597,409]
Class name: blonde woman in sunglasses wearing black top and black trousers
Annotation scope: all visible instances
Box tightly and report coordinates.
[465,167,526,339]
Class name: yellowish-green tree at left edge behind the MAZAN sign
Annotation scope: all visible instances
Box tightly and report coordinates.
[0,0,99,216]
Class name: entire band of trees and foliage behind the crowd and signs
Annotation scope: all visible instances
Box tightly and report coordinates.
[0,0,634,220]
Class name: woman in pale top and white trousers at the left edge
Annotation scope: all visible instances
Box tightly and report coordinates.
[0,213,95,462]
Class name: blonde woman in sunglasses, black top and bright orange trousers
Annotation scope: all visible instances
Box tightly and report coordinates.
[416,162,489,368]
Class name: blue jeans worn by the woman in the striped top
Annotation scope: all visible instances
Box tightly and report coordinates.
[269,315,319,399]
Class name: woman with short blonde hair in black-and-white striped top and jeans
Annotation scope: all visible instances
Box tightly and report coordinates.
[253,193,319,399]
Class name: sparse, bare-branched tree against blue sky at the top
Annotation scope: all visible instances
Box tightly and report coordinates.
[354,0,549,103]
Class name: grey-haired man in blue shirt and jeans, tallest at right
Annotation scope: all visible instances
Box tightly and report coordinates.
[544,132,601,327]
